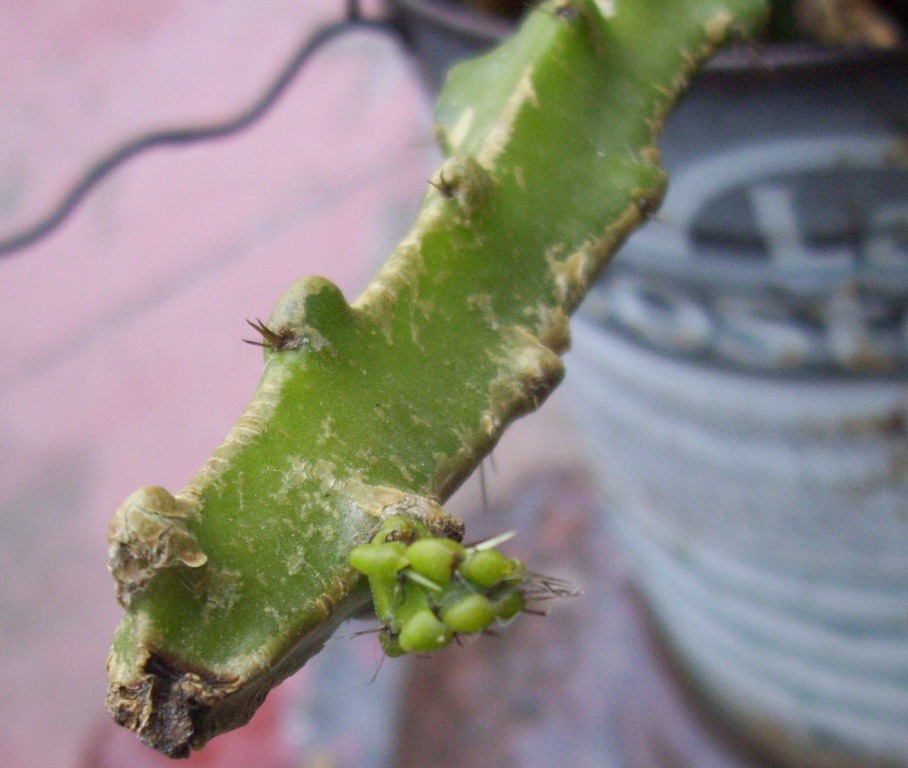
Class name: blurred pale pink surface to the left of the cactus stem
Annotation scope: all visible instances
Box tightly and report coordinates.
[0,0,433,768]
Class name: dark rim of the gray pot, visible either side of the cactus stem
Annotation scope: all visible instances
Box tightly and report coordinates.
[386,0,908,76]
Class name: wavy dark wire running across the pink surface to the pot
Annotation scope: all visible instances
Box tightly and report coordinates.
[0,13,397,257]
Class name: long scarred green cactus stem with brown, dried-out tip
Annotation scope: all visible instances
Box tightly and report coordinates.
[107,0,762,755]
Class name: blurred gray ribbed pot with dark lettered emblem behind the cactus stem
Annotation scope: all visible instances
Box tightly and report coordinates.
[389,0,908,768]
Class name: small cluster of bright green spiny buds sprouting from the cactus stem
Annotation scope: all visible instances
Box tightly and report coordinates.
[350,516,570,656]
